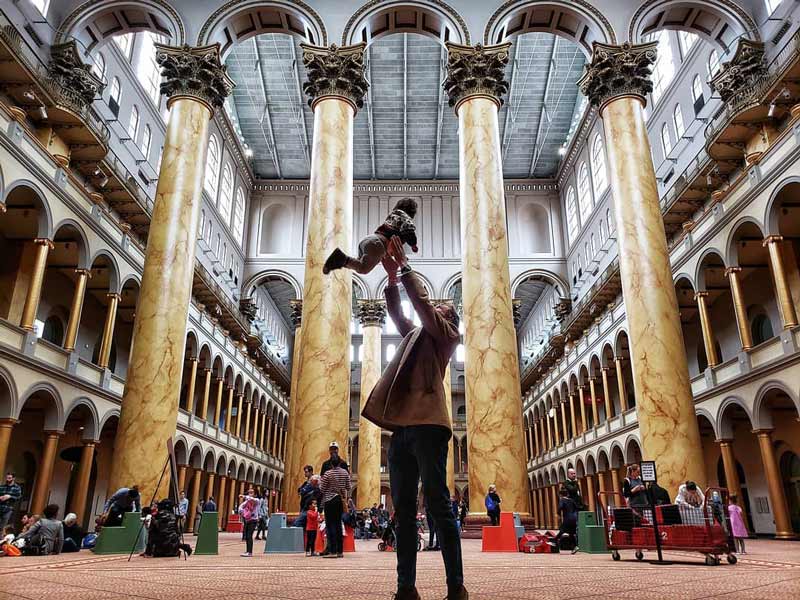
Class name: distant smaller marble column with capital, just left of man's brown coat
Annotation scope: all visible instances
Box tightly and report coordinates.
[358,300,386,506]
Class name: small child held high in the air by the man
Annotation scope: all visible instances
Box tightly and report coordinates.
[322,198,417,275]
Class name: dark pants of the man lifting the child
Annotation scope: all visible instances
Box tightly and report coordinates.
[389,425,464,588]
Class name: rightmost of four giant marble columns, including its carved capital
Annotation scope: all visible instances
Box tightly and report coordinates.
[579,42,706,495]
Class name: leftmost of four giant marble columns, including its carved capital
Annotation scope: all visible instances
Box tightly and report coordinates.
[109,44,233,498]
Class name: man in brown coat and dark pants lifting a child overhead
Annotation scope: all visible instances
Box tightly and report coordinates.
[362,237,469,600]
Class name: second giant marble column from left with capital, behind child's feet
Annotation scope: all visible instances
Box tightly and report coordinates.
[286,43,369,496]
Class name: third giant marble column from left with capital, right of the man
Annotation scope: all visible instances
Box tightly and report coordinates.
[444,43,530,513]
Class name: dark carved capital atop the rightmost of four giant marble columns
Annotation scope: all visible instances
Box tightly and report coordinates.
[578,42,658,110]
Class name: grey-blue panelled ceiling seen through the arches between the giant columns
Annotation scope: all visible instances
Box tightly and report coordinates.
[226,33,585,179]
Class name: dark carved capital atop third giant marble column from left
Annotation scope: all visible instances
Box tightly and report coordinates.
[442,42,511,113]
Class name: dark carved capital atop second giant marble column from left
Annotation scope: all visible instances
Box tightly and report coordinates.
[300,42,369,112]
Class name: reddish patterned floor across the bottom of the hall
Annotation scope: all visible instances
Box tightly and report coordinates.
[0,534,800,600]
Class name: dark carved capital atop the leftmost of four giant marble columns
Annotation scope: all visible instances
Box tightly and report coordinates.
[155,44,235,115]
